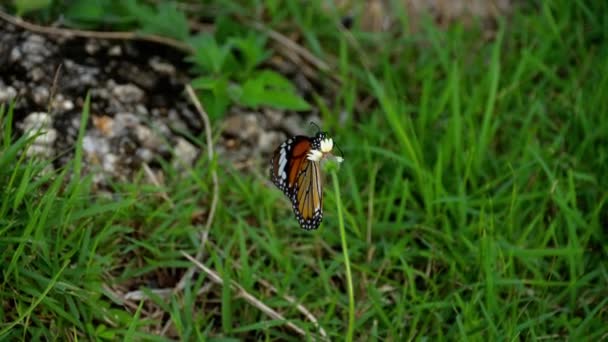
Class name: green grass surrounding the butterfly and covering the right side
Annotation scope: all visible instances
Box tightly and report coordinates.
[0,0,608,341]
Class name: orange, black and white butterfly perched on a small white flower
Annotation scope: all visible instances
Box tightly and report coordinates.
[270,128,342,230]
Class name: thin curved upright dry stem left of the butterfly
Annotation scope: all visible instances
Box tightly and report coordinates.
[175,84,219,291]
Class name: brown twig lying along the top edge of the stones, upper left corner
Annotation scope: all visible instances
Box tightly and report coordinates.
[0,11,194,53]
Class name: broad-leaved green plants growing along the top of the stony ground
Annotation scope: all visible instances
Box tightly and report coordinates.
[15,0,310,118]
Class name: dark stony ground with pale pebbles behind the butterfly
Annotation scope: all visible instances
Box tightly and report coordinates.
[0,22,318,189]
